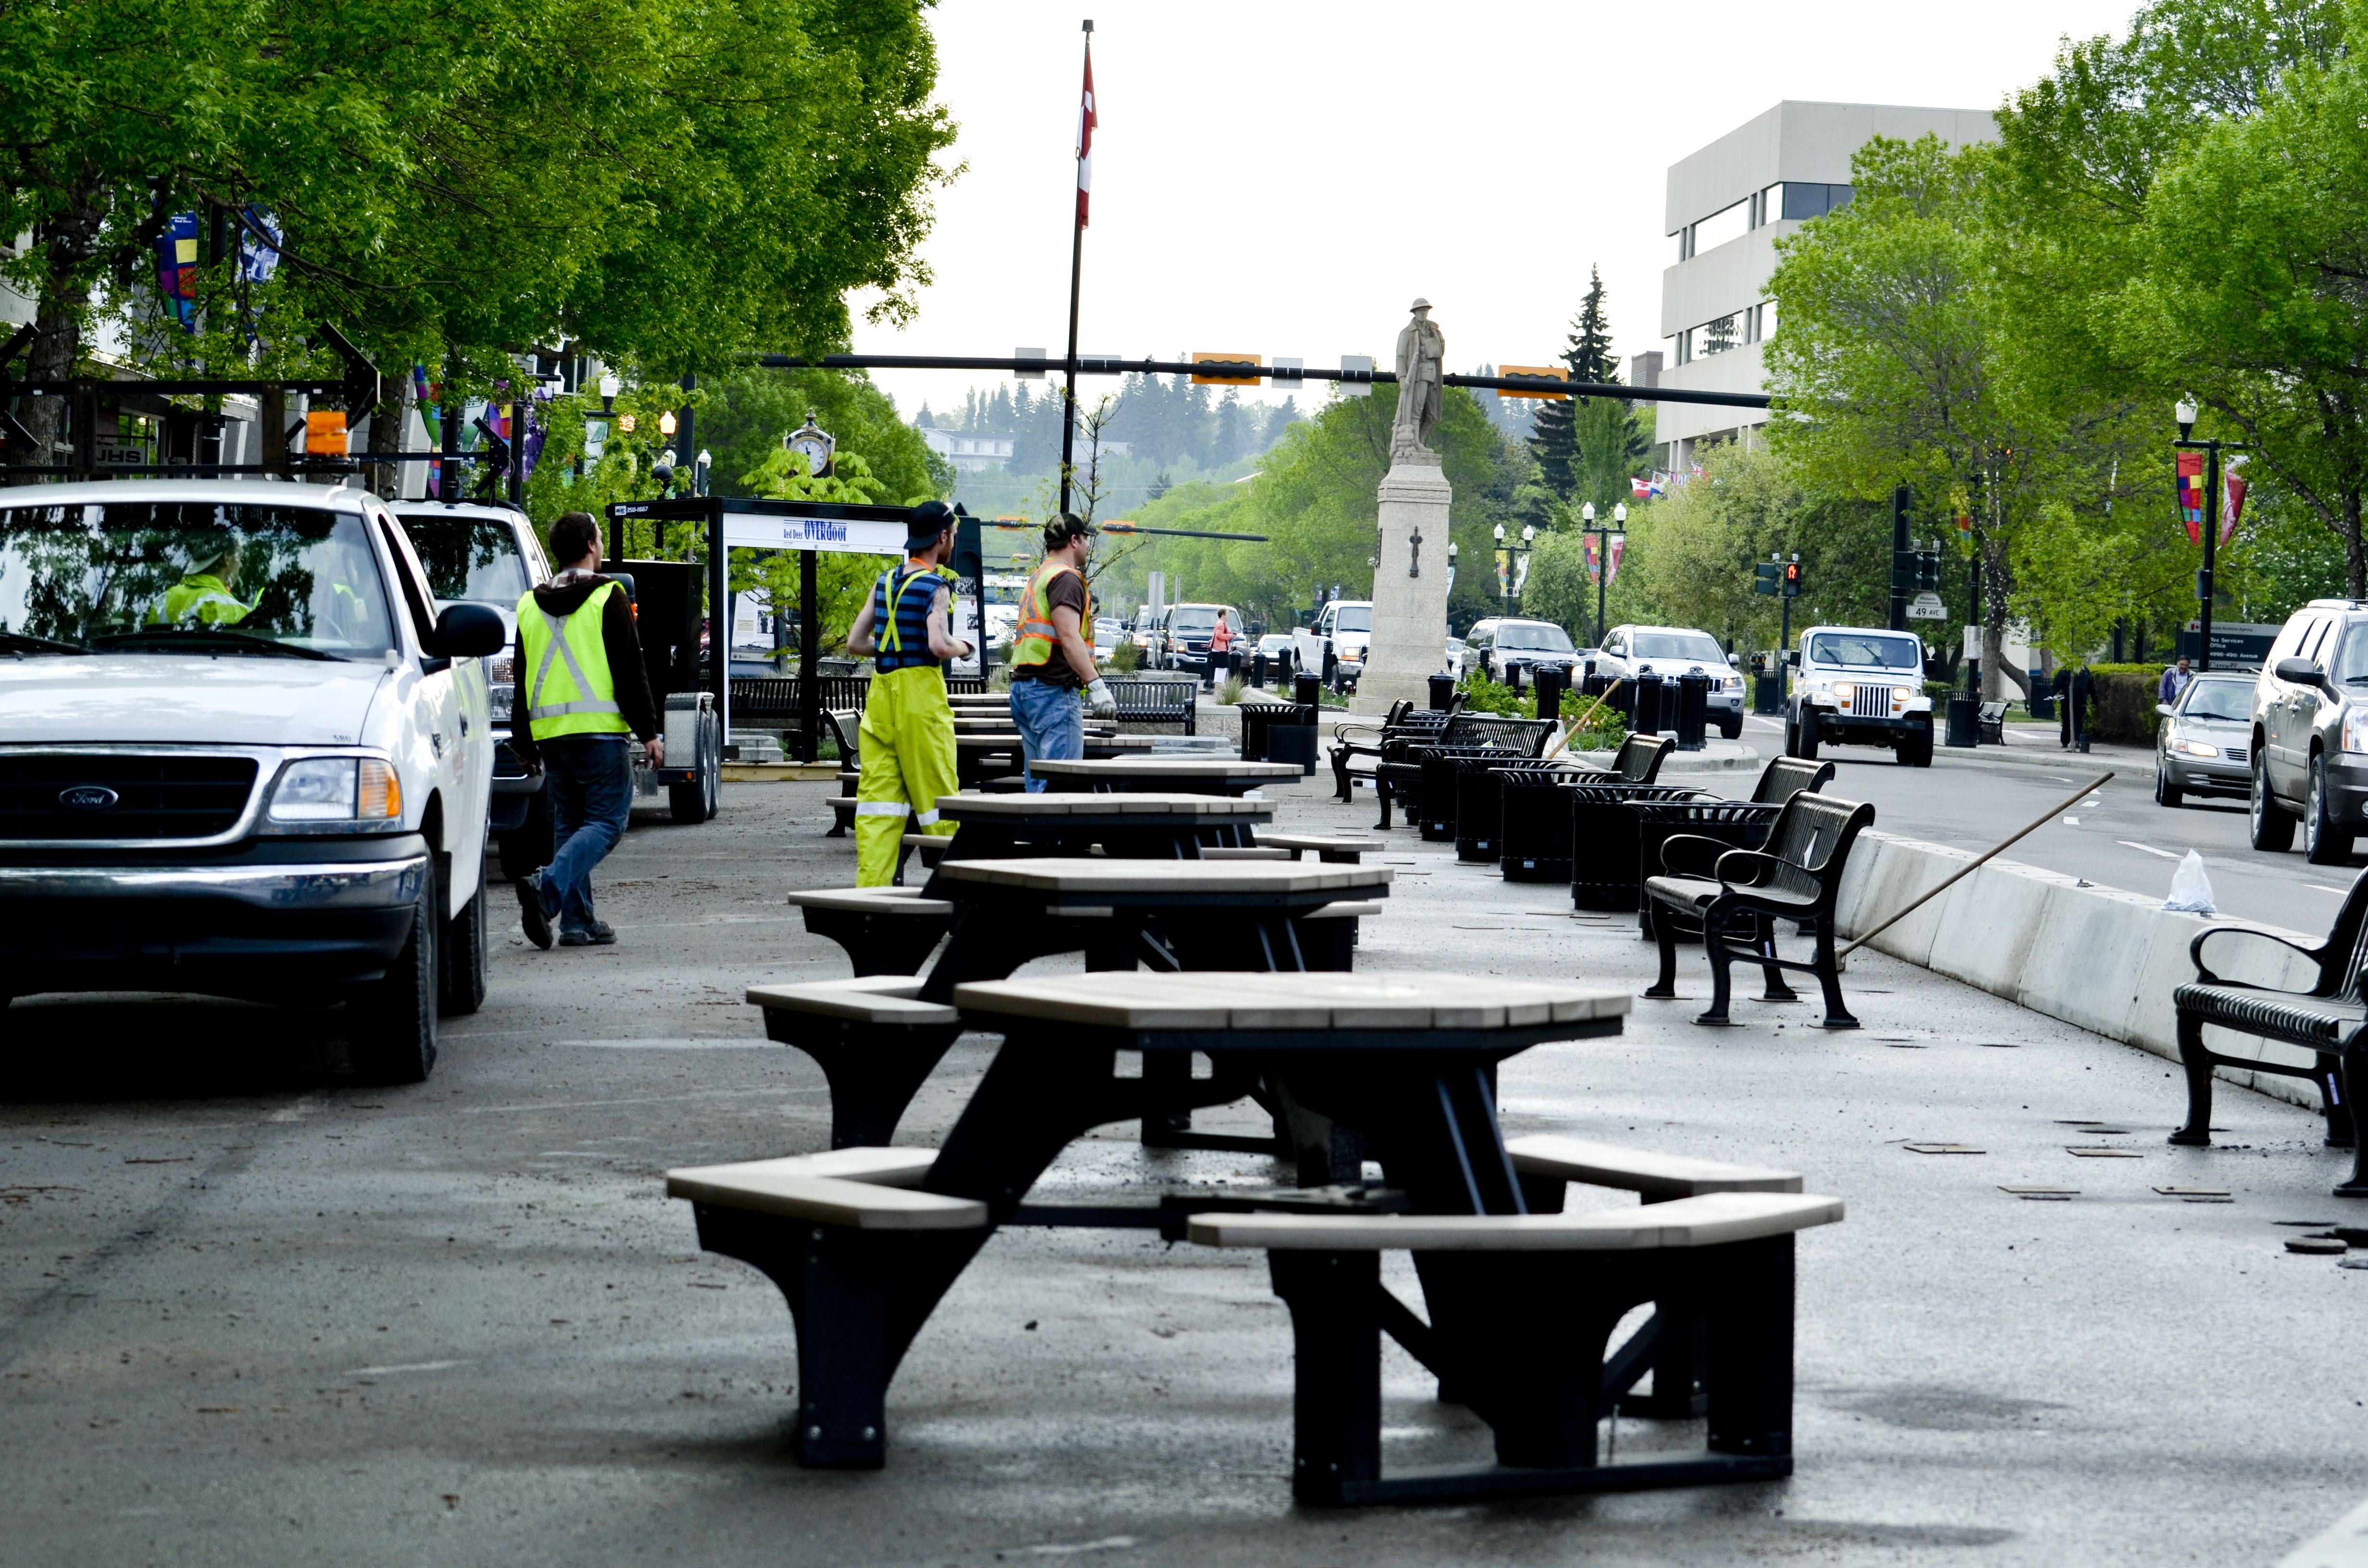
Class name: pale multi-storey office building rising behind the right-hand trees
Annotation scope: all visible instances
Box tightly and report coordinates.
[1655,102,1998,474]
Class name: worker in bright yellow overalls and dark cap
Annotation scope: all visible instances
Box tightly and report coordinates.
[848,500,971,888]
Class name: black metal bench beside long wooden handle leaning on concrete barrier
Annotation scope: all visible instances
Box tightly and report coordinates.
[1643,791,1875,1028]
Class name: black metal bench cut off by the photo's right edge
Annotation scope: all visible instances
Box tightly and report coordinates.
[2171,871,2368,1199]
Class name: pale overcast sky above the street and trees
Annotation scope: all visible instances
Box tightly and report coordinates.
[855,0,2136,419]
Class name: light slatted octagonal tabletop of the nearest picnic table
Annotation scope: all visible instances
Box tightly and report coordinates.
[954,971,1629,1030]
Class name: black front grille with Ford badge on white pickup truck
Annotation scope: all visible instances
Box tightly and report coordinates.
[0,751,256,838]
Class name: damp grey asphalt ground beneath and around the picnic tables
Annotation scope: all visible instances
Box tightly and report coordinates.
[0,782,2368,1568]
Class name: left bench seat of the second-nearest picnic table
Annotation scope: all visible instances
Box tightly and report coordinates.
[748,973,962,1149]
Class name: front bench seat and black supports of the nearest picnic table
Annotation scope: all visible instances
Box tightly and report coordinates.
[1186,1191,1842,1507]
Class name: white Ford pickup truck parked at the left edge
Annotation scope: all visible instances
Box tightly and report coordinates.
[0,481,505,1082]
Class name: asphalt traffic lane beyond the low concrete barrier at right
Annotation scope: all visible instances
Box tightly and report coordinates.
[1707,715,2368,936]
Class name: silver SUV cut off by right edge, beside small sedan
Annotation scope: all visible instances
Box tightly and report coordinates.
[2252,599,2368,865]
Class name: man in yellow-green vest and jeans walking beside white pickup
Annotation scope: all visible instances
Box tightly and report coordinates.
[509,512,666,947]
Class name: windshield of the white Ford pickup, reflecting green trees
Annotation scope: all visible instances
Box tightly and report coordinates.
[0,502,395,659]
